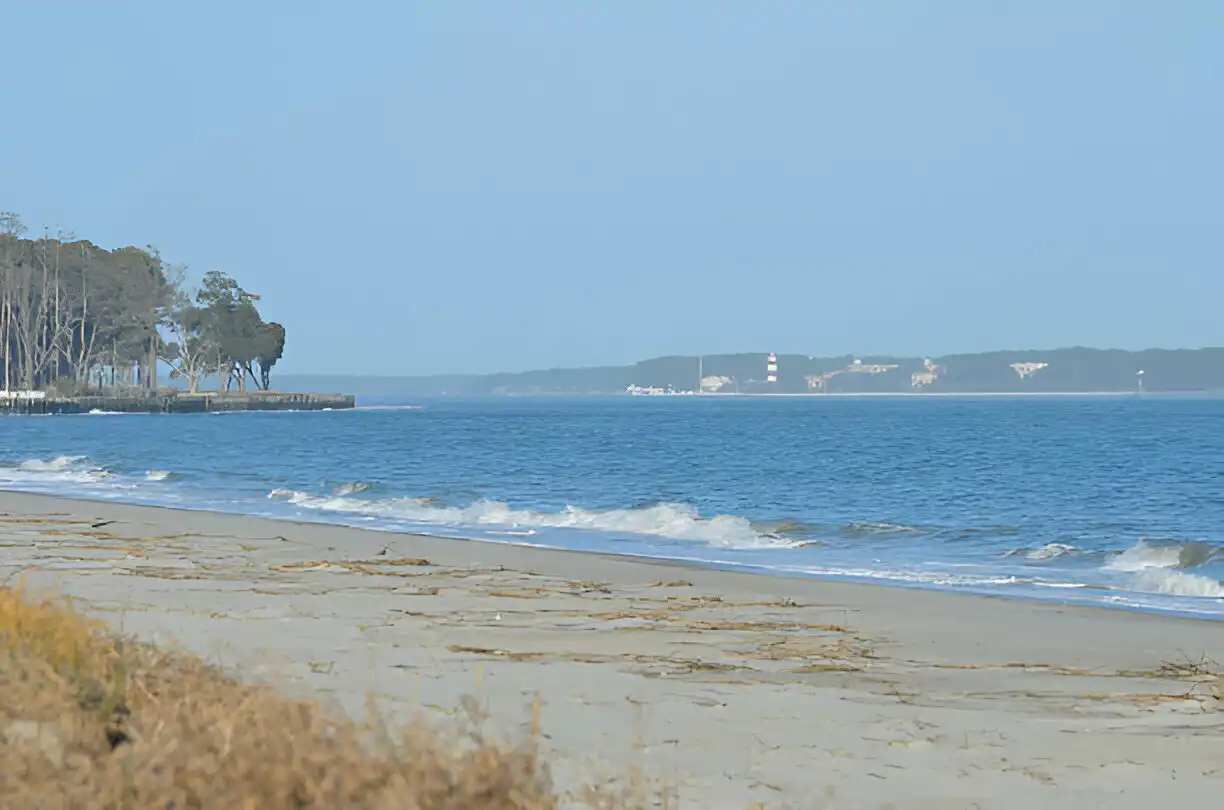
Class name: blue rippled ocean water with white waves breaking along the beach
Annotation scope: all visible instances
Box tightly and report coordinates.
[0,396,1224,618]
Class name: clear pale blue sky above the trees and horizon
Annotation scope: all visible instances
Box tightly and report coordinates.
[0,0,1224,374]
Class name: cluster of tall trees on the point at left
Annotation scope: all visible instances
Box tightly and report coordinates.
[0,212,285,394]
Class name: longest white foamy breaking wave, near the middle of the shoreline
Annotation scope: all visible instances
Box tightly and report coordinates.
[268,489,797,548]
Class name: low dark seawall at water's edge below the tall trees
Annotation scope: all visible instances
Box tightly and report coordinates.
[0,390,356,415]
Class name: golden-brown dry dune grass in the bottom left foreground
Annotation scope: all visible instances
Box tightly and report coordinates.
[0,586,630,810]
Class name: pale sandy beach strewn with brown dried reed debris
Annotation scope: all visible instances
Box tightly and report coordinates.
[0,493,1224,810]
